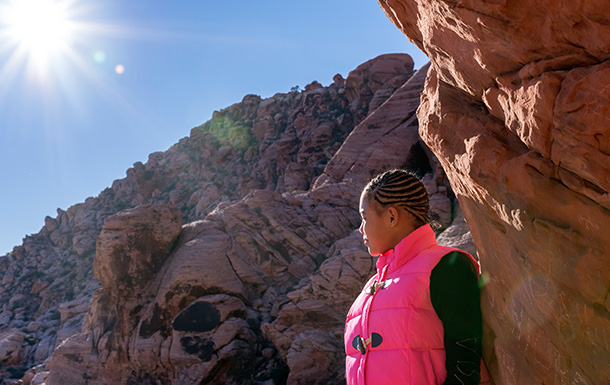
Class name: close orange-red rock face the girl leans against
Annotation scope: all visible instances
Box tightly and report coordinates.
[379,0,610,385]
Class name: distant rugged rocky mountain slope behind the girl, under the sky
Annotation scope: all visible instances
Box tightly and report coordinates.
[0,54,472,385]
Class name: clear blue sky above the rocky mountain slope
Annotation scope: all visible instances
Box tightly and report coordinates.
[0,0,427,255]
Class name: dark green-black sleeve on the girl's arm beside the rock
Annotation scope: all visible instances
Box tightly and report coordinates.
[430,252,483,385]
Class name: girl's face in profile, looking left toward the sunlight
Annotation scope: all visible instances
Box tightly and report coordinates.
[358,194,396,257]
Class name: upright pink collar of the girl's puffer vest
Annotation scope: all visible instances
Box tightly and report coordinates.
[377,224,436,276]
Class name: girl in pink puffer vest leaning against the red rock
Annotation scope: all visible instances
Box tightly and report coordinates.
[345,170,482,385]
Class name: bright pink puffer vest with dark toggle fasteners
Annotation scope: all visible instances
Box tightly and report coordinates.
[344,225,483,385]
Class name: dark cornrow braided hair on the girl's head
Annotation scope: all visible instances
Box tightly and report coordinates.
[363,169,430,224]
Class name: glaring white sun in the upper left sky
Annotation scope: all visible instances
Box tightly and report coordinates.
[0,0,73,67]
